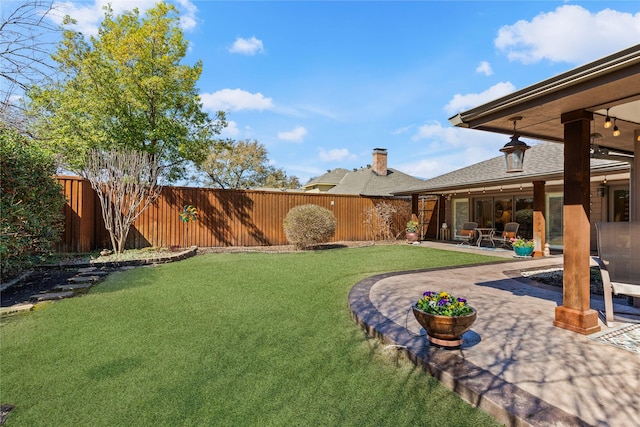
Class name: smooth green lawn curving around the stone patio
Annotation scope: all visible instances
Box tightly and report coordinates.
[0,245,498,427]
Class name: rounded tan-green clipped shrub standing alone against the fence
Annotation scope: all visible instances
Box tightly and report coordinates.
[284,205,336,249]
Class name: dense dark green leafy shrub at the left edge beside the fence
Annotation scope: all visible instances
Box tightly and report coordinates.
[0,126,65,277]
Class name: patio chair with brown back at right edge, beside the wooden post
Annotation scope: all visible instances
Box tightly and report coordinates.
[593,222,640,326]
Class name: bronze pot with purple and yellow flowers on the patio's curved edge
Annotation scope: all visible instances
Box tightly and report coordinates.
[412,291,477,348]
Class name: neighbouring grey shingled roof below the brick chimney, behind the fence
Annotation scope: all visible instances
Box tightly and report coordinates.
[328,167,424,197]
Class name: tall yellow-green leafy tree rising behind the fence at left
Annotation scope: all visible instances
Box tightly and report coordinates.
[29,3,226,182]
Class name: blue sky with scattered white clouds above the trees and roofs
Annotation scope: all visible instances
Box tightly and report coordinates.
[41,0,640,183]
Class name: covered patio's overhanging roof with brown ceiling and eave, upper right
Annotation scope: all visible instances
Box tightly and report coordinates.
[449,44,640,153]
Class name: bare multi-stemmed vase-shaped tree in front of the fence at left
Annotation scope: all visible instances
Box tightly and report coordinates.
[84,150,162,253]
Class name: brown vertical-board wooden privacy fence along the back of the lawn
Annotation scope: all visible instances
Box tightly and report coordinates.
[58,176,437,252]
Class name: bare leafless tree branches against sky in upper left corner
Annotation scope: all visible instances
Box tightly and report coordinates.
[0,0,61,130]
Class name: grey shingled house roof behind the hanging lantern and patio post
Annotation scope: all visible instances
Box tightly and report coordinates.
[395,142,630,195]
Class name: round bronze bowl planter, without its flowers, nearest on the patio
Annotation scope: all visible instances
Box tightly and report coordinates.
[412,305,477,348]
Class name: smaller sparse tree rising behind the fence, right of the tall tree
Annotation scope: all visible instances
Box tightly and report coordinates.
[201,140,300,189]
